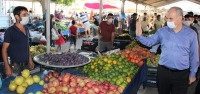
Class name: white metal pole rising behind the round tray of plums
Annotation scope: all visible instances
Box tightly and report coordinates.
[46,0,50,53]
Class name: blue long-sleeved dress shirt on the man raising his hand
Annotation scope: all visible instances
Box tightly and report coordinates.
[136,26,199,77]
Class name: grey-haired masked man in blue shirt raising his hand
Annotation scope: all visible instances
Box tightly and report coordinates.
[136,7,199,94]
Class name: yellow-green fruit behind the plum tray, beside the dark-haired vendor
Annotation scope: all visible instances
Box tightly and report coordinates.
[30,45,55,57]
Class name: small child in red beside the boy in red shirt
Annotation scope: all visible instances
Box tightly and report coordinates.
[55,29,65,52]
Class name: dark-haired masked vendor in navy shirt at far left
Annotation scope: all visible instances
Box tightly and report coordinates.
[2,6,34,77]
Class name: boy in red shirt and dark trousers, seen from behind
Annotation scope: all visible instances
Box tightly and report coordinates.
[69,20,78,52]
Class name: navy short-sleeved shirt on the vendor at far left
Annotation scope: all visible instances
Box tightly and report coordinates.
[4,24,29,62]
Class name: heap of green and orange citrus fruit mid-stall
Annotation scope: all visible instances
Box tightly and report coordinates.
[83,54,138,89]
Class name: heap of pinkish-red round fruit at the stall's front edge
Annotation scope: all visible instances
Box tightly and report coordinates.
[42,72,123,94]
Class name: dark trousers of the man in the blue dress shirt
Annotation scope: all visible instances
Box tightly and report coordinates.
[157,65,190,94]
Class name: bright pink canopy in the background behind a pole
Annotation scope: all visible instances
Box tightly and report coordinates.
[85,3,117,9]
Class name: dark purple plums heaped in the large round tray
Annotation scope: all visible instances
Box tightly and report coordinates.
[39,52,89,66]
